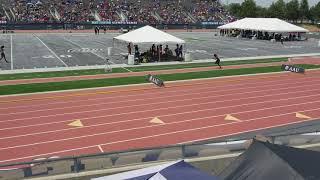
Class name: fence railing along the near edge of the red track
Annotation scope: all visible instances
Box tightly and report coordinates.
[0,131,320,179]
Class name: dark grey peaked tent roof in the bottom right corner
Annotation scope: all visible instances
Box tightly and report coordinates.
[220,140,320,180]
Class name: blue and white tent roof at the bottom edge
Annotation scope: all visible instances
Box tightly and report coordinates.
[92,160,217,180]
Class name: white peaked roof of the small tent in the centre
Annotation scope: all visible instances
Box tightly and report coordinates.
[114,26,185,44]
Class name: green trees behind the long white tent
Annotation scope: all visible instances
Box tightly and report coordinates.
[226,0,320,23]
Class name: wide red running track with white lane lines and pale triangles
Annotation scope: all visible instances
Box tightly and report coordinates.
[0,70,320,164]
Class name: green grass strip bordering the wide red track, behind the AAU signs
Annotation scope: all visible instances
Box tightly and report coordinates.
[0,65,320,95]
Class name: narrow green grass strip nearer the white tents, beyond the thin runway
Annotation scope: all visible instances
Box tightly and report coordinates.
[0,58,287,81]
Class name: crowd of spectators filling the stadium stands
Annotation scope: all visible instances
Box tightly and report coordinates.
[0,0,232,24]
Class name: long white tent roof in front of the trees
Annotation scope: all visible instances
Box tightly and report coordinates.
[218,18,308,32]
